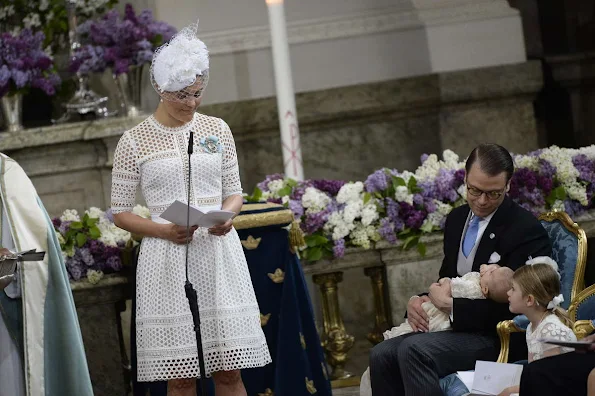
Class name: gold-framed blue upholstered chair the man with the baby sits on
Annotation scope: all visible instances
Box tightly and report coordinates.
[497,212,595,363]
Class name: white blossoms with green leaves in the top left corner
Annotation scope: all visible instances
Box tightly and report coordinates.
[0,0,118,55]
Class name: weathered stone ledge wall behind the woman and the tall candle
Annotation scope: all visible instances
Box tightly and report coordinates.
[0,62,541,215]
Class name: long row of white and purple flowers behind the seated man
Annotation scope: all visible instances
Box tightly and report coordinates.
[247,146,595,261]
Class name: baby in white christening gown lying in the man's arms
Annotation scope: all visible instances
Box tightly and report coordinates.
[360,264,514,396]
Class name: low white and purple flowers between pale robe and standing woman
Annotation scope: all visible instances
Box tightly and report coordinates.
[52,205,150,284]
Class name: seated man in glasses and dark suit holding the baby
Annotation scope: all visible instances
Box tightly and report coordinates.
[370,144,552,396]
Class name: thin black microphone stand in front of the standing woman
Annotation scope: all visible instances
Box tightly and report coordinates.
[184,131,207,396]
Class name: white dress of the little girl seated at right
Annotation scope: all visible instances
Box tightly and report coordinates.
[526,314,576,362]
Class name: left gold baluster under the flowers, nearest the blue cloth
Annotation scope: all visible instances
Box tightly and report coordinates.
[313,272,354,380]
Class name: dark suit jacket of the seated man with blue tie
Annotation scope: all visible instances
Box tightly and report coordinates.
[440,197,552,332]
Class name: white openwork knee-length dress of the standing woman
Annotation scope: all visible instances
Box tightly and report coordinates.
[112,113,271,381]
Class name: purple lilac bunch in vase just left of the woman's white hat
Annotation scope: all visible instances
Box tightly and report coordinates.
[70,4,176,75]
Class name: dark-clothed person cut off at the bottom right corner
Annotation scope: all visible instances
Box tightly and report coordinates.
[520,335,595,396]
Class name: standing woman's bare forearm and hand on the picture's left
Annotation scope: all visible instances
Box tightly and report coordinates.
[114,212,198,244]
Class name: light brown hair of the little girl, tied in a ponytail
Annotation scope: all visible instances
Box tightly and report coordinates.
[512,263,572,328]
